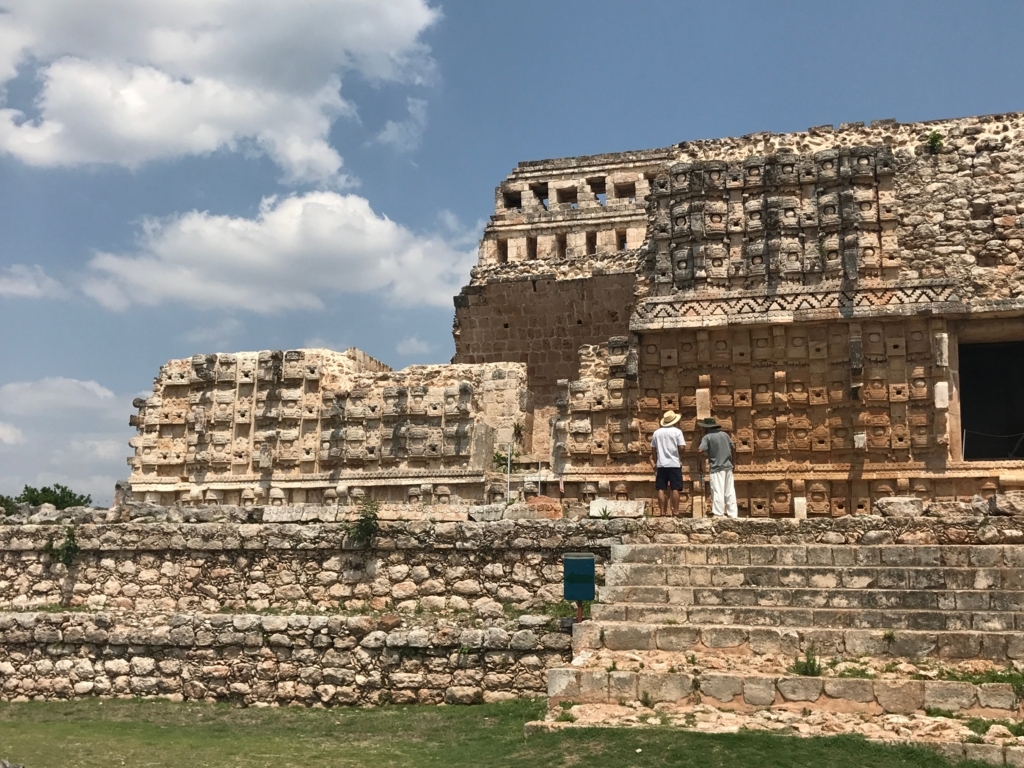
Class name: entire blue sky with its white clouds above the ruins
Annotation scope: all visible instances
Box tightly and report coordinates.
[0,0,1024,502]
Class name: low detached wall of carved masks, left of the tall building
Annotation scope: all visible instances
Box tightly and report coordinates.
[129,349,529,504]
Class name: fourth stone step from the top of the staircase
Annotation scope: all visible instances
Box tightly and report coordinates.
[591,606,1024,632]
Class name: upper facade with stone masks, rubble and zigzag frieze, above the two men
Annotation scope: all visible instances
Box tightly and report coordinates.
[632,114,1024,331]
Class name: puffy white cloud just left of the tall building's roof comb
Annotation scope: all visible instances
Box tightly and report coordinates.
[83,191,475,313]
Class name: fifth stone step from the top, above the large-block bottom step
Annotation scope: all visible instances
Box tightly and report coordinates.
[572,617,1024,663]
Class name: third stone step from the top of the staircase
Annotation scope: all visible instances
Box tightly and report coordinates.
[595,587,1024,611]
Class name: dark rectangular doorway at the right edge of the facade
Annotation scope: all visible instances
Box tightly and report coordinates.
[959,341,1024,460]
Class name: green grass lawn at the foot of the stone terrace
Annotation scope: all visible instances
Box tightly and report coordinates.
[0,699,980,768]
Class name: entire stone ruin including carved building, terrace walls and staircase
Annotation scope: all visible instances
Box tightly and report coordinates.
[0,115,1024,766]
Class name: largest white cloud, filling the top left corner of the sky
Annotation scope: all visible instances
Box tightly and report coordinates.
[0,0,440,186]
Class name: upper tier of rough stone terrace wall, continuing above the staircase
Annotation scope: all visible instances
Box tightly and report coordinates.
[0,516,1024,612]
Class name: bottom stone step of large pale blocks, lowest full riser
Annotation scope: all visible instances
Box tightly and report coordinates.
[547,668,1019,719]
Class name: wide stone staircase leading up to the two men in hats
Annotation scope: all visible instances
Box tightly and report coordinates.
[548,544,1024,718]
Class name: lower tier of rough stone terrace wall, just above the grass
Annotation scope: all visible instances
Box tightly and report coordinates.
[0,612,571,706]
